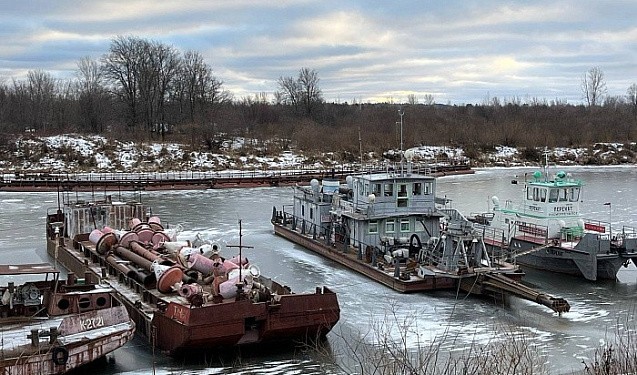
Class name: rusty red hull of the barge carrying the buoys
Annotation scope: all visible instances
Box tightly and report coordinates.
[47,209,340,356]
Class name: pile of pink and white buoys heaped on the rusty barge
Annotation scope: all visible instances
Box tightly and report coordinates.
[89,217,269,305]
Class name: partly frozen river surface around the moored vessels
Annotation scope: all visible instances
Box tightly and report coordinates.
[0,166,637,375]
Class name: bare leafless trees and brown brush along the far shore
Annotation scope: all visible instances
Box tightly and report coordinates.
[0,37,637,157]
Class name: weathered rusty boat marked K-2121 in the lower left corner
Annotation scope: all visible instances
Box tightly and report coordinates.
[0,263,135,375]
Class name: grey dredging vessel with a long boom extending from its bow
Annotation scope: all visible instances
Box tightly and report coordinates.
[272,152,570,313]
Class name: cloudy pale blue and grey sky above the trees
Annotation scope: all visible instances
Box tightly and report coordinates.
[0,0,637,104]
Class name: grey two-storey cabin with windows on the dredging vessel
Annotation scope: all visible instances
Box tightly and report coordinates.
[294,172,442,254]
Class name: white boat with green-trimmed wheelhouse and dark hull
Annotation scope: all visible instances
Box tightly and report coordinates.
[471,163,637,281]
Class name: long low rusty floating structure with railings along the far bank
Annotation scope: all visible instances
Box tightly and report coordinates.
[0,165,473,191]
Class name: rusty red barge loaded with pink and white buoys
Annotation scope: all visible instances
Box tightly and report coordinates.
[47,196,340,356]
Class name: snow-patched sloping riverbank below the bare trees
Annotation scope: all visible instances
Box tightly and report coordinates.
[0,134,637,174]
